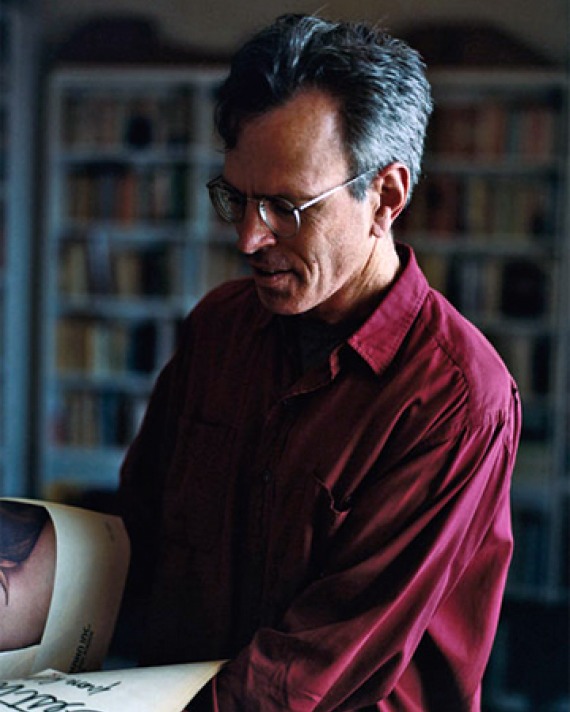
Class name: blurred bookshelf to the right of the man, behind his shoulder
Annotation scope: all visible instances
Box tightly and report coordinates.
[400,69,570,712]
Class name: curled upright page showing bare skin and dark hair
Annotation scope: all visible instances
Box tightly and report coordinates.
[0,498,130,678]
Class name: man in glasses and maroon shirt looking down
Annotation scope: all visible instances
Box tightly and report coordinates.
[121,16,520,712]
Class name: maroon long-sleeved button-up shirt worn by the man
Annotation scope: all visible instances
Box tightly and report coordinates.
[121,246,520,712]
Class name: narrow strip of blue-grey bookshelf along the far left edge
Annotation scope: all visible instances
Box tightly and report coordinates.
[0,1,36,496]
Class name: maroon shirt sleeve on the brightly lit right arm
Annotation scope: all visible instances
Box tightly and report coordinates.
[207,395,520,712]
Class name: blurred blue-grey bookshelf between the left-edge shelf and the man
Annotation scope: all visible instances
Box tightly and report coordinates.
[40,66,246,493]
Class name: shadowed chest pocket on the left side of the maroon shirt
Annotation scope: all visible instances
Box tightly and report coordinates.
[164,419,234,550]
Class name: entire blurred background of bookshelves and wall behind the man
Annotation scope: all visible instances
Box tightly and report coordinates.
[0,0,570,712]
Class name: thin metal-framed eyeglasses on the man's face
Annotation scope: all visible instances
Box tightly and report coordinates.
[206,169,376,237]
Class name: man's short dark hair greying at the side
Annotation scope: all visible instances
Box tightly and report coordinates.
[215,15,433,198]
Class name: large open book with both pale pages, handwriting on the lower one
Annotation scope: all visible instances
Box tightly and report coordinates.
[0,498,222,712]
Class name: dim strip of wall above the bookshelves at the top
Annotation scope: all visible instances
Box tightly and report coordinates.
[40,0,570,63]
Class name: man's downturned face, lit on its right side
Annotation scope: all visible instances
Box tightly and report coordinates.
[223,90,377,323]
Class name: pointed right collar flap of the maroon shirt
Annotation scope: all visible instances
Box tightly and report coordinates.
[348,243,429,375]
